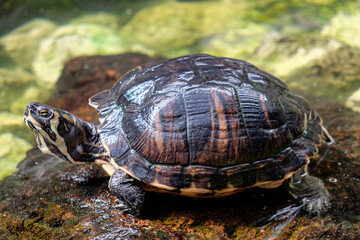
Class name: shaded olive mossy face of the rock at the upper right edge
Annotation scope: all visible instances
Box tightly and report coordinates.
[287,45,360,103]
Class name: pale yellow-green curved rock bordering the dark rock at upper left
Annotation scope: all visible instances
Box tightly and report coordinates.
[32,23,124,88]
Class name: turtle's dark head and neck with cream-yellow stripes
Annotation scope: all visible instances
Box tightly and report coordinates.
[24,102,106,163]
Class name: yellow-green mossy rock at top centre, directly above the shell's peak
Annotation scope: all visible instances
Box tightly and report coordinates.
[121,2,247,55]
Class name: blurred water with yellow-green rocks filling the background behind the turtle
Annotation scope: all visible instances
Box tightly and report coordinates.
[0,0,360,238]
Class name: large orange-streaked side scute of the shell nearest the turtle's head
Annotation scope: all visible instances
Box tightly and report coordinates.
[122,92,189,165]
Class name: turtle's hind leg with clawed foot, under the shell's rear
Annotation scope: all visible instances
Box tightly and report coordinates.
[286,168,330,215]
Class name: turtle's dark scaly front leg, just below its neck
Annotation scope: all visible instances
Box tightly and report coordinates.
[109,169,145,216]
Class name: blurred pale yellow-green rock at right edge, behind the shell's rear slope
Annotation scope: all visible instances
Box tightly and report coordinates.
[253,34,360,103]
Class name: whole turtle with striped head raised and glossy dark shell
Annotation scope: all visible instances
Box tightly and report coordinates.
[24,54,334,219]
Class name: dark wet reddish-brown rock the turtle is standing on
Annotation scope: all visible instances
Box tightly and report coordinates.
[0,55,360,239]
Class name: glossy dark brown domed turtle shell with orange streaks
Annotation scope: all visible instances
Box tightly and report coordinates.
[90,54,322,197]
